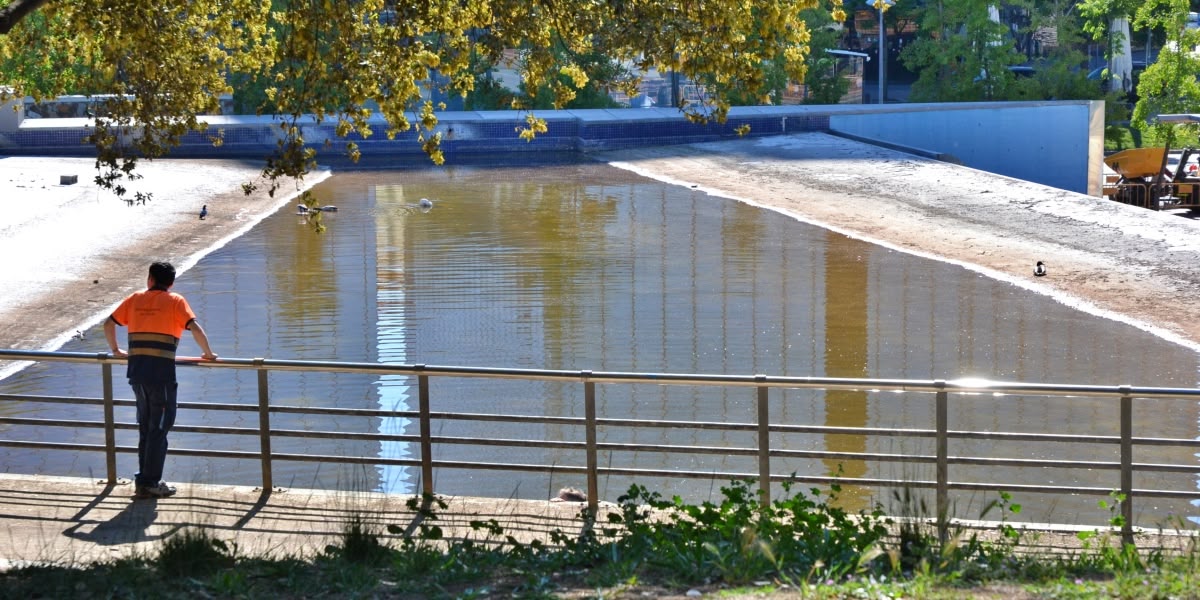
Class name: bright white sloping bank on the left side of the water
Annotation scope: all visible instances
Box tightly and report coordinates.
[0,157,329,376]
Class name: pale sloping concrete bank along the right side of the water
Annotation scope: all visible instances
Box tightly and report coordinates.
[599,133,1200,349]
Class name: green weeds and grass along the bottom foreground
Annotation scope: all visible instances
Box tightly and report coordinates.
[0,482,1200,598]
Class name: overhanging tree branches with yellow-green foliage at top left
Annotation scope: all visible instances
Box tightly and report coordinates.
[0,0,845,201]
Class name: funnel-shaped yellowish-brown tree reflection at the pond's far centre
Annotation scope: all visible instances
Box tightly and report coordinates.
[391,167,619,366]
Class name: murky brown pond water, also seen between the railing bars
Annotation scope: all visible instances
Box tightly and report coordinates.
[0,164,1200,522]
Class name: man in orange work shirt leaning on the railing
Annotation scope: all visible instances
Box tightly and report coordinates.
[104,262,217,498]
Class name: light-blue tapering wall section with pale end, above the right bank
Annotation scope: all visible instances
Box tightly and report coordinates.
[829,101,1104,196]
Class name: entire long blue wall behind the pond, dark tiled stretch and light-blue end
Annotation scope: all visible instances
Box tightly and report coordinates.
[0,101,1104,194]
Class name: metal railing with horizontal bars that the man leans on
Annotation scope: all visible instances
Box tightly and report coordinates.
[0,349,1200,542]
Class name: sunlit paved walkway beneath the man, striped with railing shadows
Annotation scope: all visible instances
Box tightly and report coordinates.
[0,474,587,571]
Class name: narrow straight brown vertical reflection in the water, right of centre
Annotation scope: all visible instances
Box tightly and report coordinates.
[824,234,870,500]
